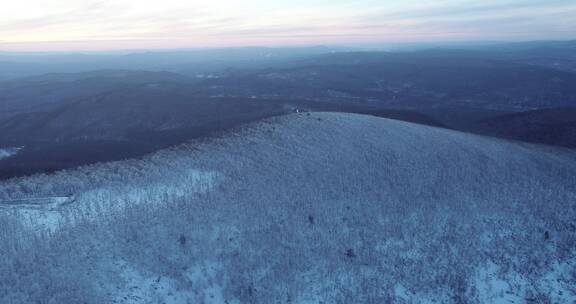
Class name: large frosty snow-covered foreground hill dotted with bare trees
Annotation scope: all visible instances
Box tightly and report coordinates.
[0,113,576,303]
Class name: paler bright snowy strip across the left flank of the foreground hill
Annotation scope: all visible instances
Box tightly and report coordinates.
[0,169,218,233]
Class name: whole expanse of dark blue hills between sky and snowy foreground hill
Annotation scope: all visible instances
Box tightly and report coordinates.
[0,42,576,178]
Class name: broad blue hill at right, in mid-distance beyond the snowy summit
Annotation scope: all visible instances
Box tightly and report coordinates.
[202,51,576,111]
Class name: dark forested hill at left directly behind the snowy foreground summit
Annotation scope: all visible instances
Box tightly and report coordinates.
[0,70,446,179]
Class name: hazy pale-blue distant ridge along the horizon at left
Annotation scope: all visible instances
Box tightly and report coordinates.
[0,46,346,80]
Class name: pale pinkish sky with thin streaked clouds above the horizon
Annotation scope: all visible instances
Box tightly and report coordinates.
[0,0,576,51]
